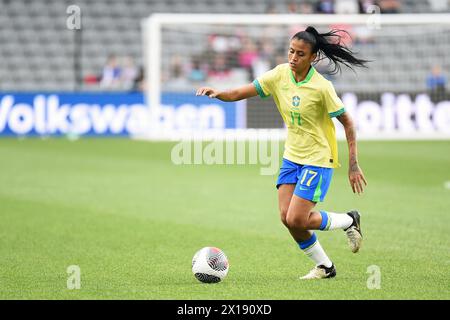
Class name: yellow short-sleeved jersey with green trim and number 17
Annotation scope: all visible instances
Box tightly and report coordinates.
[253,63,345,168]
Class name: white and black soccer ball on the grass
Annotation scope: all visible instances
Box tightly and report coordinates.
[192,247,229,283]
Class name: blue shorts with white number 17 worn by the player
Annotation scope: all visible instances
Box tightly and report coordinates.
[277,158,333,202]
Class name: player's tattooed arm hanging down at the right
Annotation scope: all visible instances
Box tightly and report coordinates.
[337,112,367,194]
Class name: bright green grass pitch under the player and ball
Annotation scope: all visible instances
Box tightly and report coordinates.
[0,138,450,300]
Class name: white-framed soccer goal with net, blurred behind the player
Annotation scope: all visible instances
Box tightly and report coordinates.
[142,12,450,139]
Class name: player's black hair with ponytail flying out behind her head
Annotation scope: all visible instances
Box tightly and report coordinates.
[292,26,370,74]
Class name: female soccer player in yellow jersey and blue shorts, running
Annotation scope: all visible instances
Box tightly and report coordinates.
[197,27,367,279]
